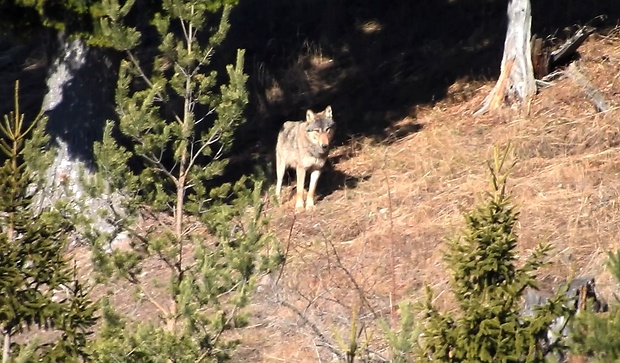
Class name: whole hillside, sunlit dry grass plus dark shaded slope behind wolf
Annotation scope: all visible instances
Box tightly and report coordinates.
[0,0,620,363]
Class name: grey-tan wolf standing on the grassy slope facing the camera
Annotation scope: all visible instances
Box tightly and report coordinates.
[276,106,336,210]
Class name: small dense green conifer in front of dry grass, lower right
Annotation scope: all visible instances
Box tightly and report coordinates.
[418,149,568,362]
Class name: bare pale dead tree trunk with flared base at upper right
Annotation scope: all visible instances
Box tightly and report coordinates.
[475,0,536,115]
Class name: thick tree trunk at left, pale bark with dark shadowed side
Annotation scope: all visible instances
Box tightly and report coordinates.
[41,33,120,242]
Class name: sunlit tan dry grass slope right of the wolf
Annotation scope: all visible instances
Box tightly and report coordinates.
[241,34,620,362]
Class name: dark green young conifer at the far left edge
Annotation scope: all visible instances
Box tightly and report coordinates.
[0,83,96,363]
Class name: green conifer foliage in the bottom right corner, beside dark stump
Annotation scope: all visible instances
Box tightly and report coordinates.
[570,251,620,362]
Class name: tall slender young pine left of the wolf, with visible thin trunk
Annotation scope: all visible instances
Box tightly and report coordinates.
[89,0,280,362]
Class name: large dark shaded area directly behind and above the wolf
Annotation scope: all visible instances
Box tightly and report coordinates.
[225,0,620,158]
